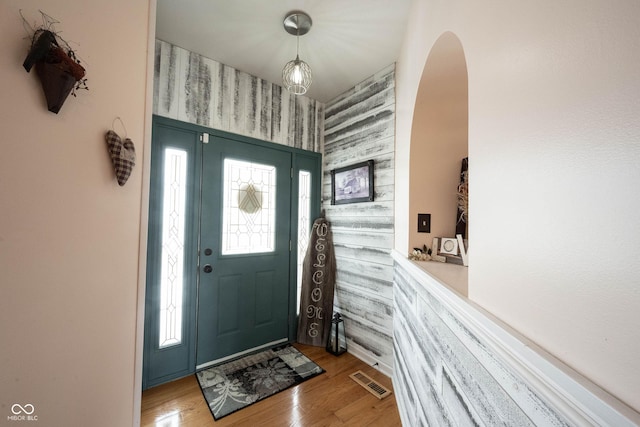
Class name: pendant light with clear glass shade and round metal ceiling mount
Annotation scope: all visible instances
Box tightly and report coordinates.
[282,11,311,95]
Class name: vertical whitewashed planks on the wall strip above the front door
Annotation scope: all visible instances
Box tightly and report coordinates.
[153,40,324,152]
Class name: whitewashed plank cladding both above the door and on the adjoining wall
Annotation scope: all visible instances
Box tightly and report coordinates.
[153,40,395,376]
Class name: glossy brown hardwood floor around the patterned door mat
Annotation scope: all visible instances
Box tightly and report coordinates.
[141,344,401,427]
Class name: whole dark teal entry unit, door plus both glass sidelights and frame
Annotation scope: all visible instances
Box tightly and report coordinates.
[143,117,321,389]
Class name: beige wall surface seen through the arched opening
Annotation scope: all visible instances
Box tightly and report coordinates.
[408,32,469,260]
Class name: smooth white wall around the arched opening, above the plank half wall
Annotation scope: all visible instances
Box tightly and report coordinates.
[395,0,640,411]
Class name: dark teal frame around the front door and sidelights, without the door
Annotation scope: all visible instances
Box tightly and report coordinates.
[142,115,323,390]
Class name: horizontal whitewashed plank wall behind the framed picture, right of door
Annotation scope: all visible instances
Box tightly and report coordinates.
[323,65,395,376]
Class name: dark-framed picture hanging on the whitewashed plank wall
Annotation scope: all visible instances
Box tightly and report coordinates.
[331,160,374,205]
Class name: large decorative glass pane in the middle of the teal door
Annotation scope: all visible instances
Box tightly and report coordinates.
[221,158,276,255]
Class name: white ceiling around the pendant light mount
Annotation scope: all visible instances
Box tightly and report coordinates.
[156,0,411,102]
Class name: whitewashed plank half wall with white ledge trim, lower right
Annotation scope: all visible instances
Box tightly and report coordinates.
[392,251,637,427]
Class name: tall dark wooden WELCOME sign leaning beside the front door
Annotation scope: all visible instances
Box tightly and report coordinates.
[298,218,336,347]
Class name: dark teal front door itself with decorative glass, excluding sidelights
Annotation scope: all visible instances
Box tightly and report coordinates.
[197,137,292,367]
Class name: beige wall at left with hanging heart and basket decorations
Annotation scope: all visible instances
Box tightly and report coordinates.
[0,0,154,427]
